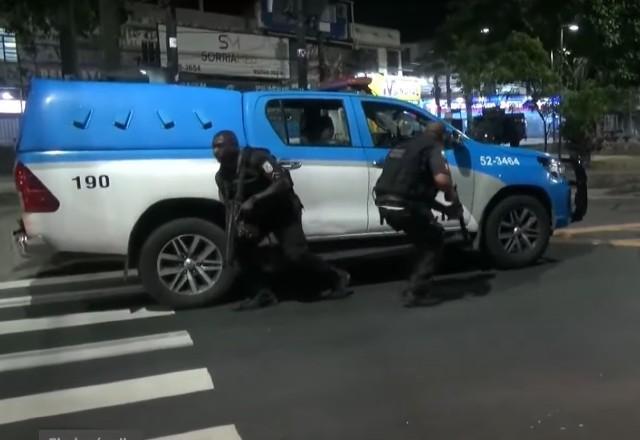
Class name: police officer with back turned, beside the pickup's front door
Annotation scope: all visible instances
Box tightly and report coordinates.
[375,122,462,307]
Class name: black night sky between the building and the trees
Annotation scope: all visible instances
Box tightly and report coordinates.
[354,0,450,42]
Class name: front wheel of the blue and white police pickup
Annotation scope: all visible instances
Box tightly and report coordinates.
[483,195,551,269]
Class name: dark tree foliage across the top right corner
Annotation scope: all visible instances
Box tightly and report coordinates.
[437,0,640,86]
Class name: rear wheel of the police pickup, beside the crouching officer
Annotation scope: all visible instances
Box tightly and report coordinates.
[138,218,235,308]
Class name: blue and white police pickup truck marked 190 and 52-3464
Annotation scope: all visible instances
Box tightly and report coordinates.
[14,79,586,307]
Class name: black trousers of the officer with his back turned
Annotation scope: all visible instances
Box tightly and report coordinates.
[382,208,444,294]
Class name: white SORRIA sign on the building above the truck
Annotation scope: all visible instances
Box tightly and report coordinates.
[158,25,289,79]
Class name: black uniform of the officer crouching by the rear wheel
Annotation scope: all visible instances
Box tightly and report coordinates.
[216,148,344,300]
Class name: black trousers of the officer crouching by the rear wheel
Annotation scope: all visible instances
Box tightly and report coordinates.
[236,209,339,294]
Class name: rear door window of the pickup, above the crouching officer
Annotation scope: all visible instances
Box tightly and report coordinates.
[267,99,351,147]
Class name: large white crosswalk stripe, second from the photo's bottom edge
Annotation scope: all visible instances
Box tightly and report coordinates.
[0,368,213,425]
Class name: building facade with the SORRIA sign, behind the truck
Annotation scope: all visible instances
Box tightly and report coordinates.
[0,0,402,89]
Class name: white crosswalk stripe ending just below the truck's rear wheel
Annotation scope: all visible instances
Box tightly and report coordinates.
[0,309,174,335]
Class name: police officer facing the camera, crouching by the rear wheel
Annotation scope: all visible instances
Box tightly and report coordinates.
[212,130,351,310]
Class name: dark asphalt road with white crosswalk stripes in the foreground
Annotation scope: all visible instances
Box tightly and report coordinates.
[0,192,640,440]
